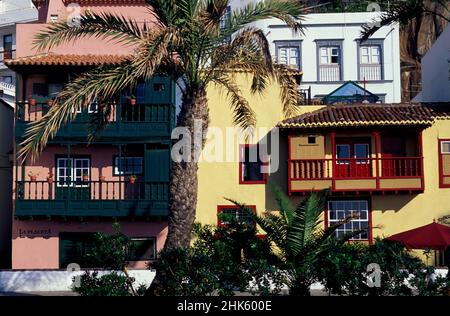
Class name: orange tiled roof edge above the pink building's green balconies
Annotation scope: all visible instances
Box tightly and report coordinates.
[5,54,127,68]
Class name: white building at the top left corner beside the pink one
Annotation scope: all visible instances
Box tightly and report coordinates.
[0,0,37,105]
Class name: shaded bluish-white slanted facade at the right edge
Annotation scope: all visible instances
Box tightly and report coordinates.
[413,25,450,102]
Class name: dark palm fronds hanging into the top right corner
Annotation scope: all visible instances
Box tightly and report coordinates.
[361,0,450,41]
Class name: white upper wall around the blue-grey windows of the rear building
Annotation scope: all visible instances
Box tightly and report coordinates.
[232,0,401,103]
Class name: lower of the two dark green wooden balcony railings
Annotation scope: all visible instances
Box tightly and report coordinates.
[15,181,169,219]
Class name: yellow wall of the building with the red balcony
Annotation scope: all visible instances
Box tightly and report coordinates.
[197,75,450,264]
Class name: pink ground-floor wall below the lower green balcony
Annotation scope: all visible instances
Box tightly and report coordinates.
[12,220,167,269]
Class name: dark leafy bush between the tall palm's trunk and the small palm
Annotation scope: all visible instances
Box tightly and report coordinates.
[152,219,283,296]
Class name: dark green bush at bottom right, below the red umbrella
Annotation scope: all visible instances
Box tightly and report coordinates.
[316,239,449,296]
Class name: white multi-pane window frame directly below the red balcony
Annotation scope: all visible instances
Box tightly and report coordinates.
[327,200,371,240]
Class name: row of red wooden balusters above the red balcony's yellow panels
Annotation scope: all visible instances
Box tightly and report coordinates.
[289,157,422,180]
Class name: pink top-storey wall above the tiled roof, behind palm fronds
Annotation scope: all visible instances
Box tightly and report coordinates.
[16,0,154,57]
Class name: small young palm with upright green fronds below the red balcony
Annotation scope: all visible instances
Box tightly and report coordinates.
[255,187,362,295]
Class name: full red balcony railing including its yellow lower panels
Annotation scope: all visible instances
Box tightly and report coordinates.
[289,157,423,192]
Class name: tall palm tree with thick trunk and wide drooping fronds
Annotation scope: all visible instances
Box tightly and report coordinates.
[20,0,304,248]
